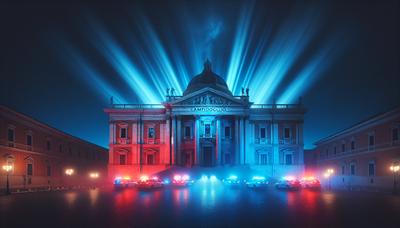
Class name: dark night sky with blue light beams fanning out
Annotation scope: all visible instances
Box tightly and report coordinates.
[0,1,400,148]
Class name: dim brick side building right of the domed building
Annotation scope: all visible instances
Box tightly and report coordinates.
[313,108,400,190]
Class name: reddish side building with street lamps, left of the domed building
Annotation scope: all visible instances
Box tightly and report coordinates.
[0,106,108,190]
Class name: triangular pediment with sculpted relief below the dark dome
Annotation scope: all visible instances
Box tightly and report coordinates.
[170,87,247,106]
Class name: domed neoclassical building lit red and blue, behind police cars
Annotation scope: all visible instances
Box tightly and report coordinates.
[105,62,305,178]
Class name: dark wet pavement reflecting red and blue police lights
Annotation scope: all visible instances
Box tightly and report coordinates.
[0,182,400,228]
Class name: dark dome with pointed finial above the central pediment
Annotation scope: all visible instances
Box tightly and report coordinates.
[183,60,232,96]
